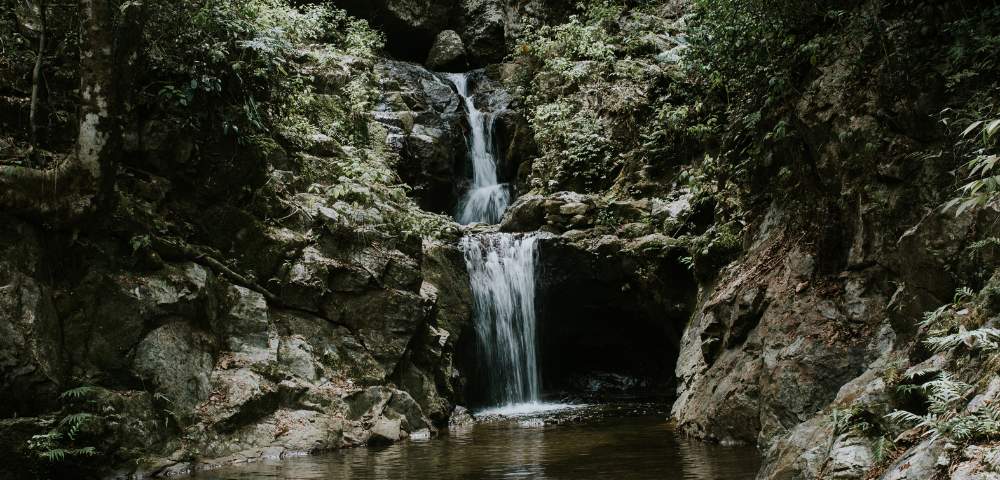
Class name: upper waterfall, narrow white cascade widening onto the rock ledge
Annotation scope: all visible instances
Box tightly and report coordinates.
[448,73,510,225]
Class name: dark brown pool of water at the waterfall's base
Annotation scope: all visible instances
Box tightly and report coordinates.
[196,405,760,480]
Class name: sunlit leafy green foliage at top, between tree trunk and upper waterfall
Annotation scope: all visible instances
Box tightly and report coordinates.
[142,0,381,139]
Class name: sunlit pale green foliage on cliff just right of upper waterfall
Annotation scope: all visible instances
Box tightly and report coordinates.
[509,2,676,193]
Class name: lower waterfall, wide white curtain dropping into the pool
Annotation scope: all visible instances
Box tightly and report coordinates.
[462,233,540,406]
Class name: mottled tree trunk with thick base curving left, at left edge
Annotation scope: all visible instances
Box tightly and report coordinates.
[0,0,121,220]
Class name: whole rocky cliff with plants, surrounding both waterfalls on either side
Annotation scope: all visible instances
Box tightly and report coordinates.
[0,0,1000,479]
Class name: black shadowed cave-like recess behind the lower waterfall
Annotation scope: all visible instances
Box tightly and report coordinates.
[458,238,697,407]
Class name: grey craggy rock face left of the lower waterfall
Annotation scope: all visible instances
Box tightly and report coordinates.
[0,210,471,473]
